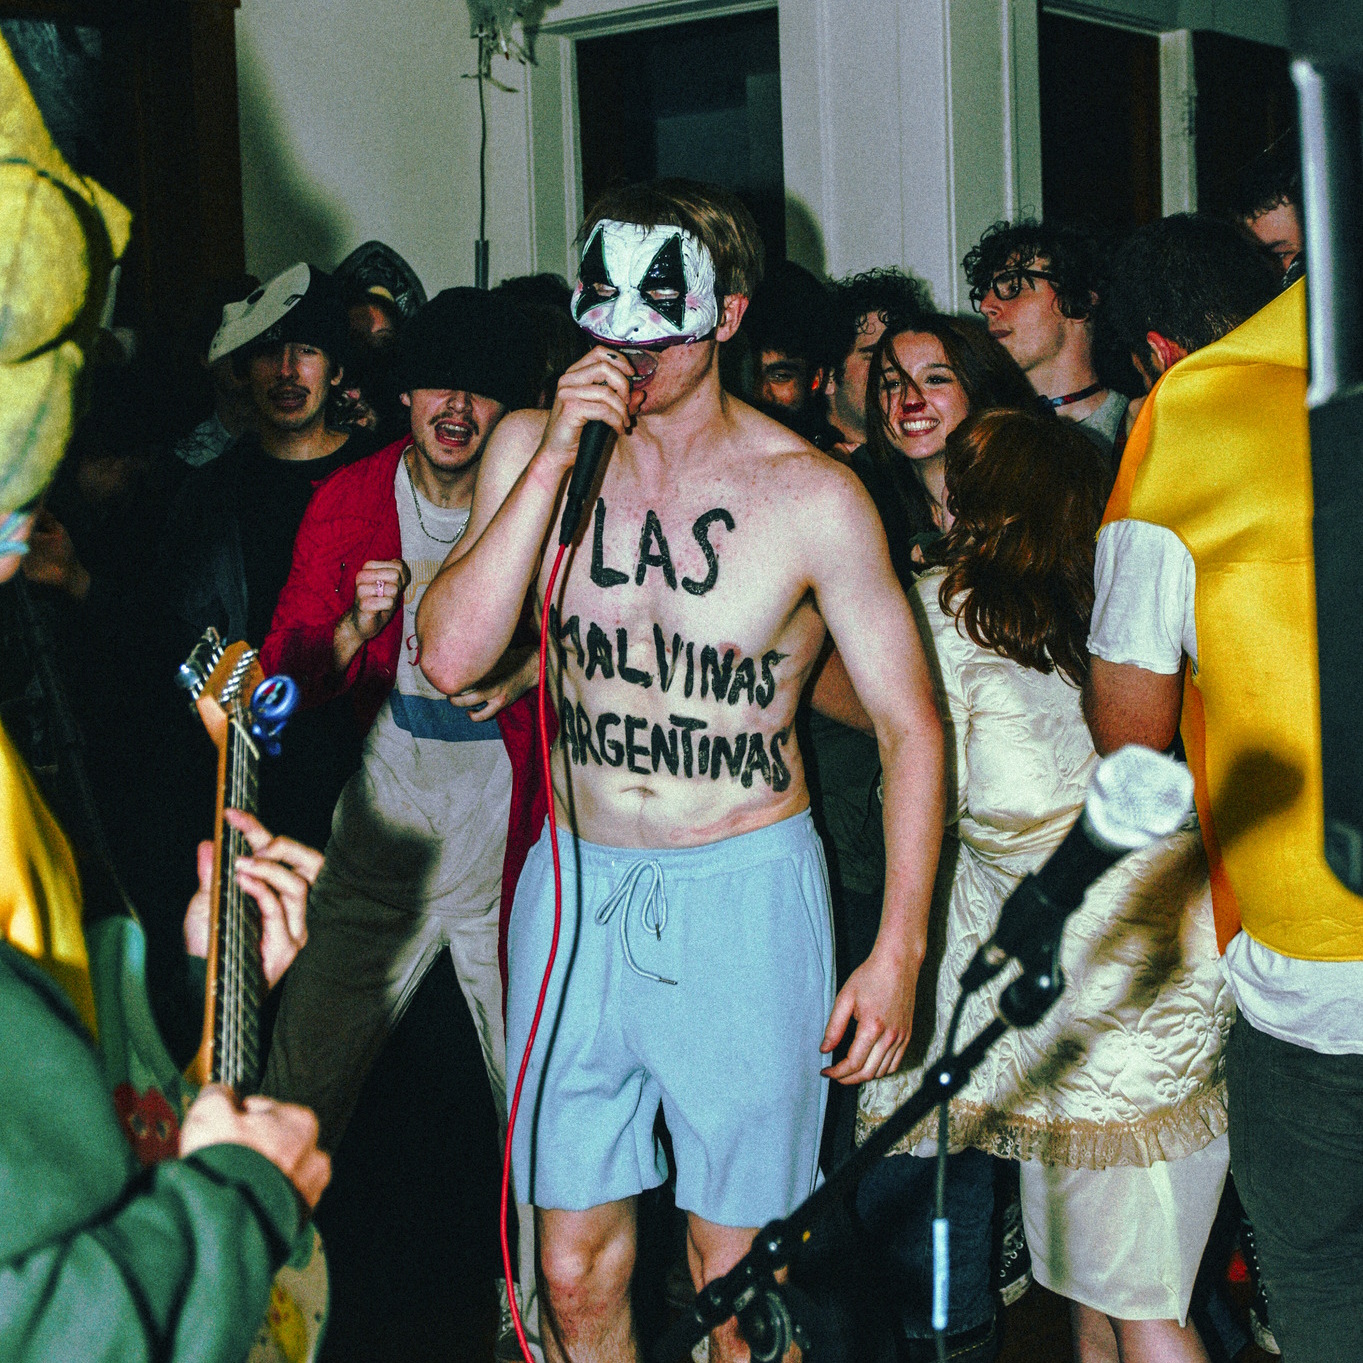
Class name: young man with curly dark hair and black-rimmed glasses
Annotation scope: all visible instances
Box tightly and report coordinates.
[961,218,1130,468]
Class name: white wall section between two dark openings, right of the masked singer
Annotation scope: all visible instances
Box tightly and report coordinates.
[781,0,1041,308]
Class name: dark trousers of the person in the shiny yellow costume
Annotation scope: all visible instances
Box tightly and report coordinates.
[1225,1018,1363,1363]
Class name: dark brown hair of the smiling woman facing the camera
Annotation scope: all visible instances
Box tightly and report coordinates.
[866,312,1051,534]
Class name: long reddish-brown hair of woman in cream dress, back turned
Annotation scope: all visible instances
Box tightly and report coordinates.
[935,412,1111,686]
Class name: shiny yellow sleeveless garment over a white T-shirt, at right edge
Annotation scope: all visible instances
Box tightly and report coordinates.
[1104,282,1363,961]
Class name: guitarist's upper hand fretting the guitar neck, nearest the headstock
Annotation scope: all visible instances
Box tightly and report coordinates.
[184,810,322,990]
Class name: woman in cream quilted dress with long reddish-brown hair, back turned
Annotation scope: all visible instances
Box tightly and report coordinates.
[859,410,1231,1363]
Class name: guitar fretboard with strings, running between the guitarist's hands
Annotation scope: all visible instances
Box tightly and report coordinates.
[211,716,266,1094]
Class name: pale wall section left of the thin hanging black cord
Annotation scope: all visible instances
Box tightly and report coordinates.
[237,0,506,293]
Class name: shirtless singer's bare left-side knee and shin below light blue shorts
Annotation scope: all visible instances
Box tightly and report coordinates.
[536,1198,635,1363]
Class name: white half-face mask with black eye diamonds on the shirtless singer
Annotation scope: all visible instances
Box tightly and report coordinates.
[572,221,720,346]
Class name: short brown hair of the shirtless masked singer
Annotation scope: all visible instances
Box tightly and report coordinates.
[578,180,763,301]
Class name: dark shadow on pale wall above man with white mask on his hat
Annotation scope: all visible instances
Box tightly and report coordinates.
[237,29,350,279]
